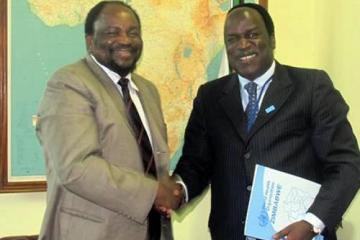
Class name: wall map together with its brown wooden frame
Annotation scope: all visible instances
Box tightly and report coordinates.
[0,0,267,192]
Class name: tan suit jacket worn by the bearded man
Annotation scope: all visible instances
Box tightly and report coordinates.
[36,56,172,240]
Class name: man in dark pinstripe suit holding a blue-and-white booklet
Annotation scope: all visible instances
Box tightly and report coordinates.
[175,4,360,240]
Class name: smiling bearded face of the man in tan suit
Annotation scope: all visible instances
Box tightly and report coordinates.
[86,4,143,76]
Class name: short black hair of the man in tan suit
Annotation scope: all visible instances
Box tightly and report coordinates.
[85,1,141,36]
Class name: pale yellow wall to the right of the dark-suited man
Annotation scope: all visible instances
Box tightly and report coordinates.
[260,0,360,240]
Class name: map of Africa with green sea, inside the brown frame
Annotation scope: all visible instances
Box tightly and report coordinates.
[11,0,231,176]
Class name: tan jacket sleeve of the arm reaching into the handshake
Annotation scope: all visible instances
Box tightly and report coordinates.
[37,71,157,223]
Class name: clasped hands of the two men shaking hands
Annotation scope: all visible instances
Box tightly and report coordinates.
[154,176,185,218]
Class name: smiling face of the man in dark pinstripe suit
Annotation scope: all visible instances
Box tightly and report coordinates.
[224,7,275,80]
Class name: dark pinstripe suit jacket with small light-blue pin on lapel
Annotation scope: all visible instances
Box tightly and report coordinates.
[175,63,360,240]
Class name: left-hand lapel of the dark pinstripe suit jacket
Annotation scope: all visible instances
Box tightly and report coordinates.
[219,74,246,141]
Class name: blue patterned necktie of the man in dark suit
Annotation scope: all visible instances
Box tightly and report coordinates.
[244,82,258,132]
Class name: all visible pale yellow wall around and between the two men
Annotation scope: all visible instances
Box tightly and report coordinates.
[0,0,360,240]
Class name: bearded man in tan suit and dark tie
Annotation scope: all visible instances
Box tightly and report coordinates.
[36,1,179,240]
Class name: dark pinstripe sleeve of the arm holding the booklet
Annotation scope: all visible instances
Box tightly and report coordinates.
[309,71,360,228]
